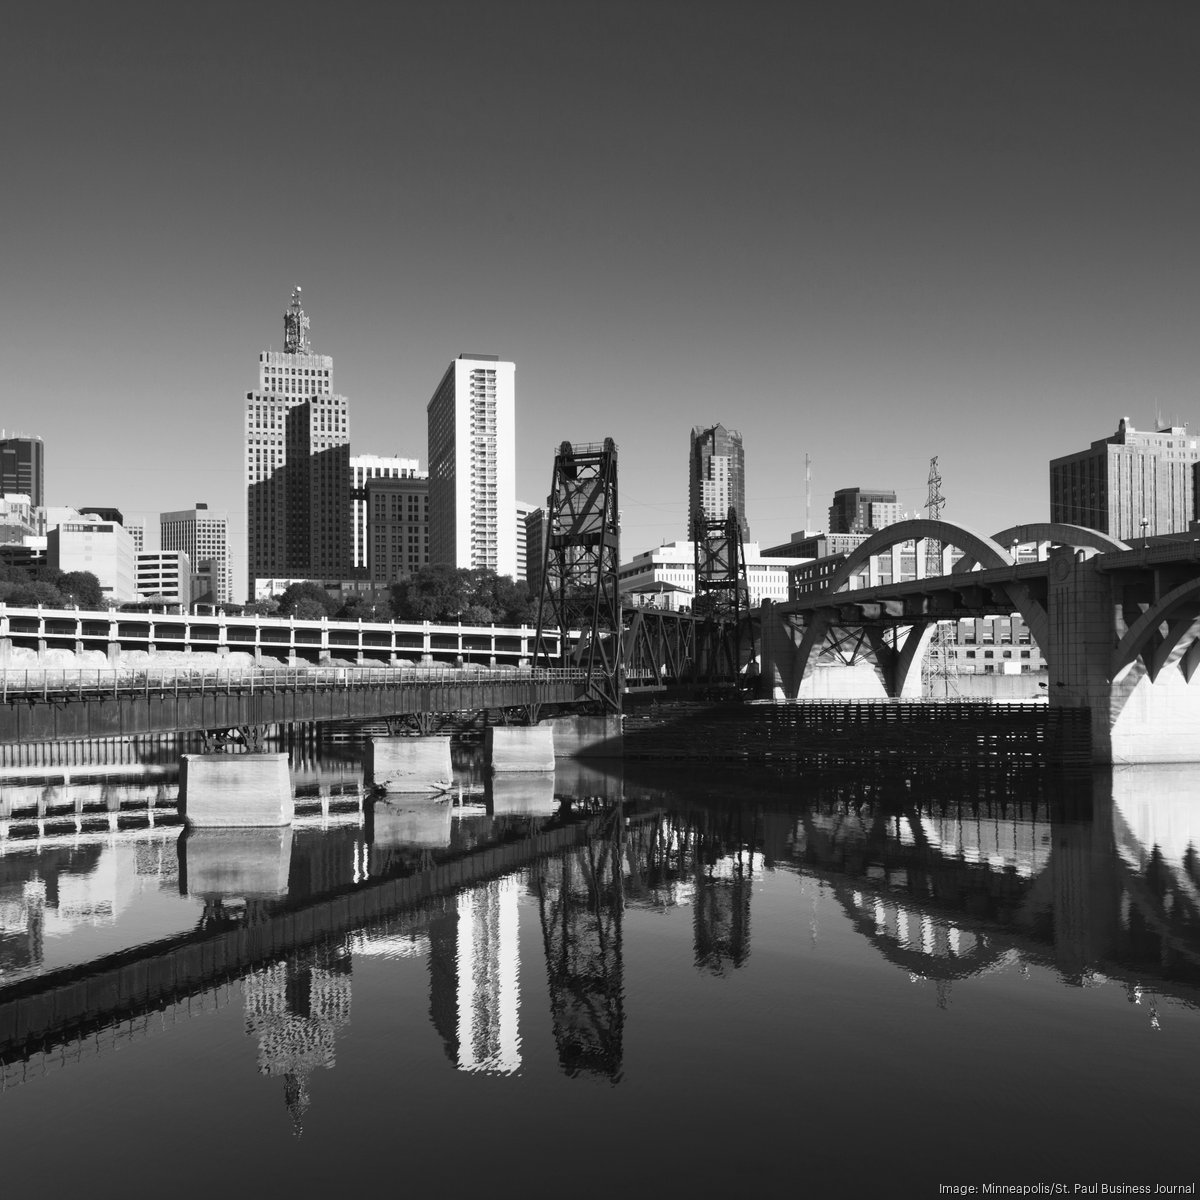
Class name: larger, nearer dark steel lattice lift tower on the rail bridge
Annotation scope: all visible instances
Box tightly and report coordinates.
[534,438,623,713]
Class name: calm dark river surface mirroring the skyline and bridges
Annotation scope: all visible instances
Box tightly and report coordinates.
[0,756,1200,1196]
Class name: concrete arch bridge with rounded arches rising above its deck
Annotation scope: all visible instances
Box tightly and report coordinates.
[760,520,1200,763]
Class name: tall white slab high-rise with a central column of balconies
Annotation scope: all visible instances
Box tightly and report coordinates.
[426,354,517,577]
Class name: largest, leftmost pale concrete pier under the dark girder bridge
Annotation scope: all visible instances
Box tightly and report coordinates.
[179,754,295,828]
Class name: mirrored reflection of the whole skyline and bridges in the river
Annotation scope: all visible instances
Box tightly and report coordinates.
[0,763,1200,1130]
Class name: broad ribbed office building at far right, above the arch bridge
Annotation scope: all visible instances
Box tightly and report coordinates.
[1050,416,1200,541]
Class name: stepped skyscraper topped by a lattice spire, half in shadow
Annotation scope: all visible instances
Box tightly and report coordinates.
[246,288,352,595]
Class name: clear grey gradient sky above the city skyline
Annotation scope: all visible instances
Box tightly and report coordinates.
[7,0,1200,590]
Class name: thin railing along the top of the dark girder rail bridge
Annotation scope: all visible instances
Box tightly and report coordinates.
[0,666,587,700]
